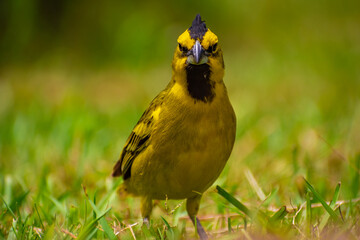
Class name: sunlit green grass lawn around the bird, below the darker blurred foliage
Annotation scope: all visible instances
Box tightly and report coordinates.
[0,67,360,239]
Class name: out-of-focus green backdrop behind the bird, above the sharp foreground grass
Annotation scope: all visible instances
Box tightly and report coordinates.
[0,0,360,238]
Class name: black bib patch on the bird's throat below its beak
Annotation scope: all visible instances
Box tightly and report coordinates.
[186,64,215,102]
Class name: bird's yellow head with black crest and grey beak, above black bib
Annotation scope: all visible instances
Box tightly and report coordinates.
[173,14,224,82]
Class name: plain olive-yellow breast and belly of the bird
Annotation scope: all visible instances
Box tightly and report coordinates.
[125,93,235,199]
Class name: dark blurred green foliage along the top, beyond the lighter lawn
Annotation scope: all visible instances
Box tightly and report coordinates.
[0,0,360,71]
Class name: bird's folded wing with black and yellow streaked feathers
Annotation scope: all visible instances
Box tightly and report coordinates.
[112,89,167,180]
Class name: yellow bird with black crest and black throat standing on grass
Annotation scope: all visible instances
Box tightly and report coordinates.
[112,14,236,239]
